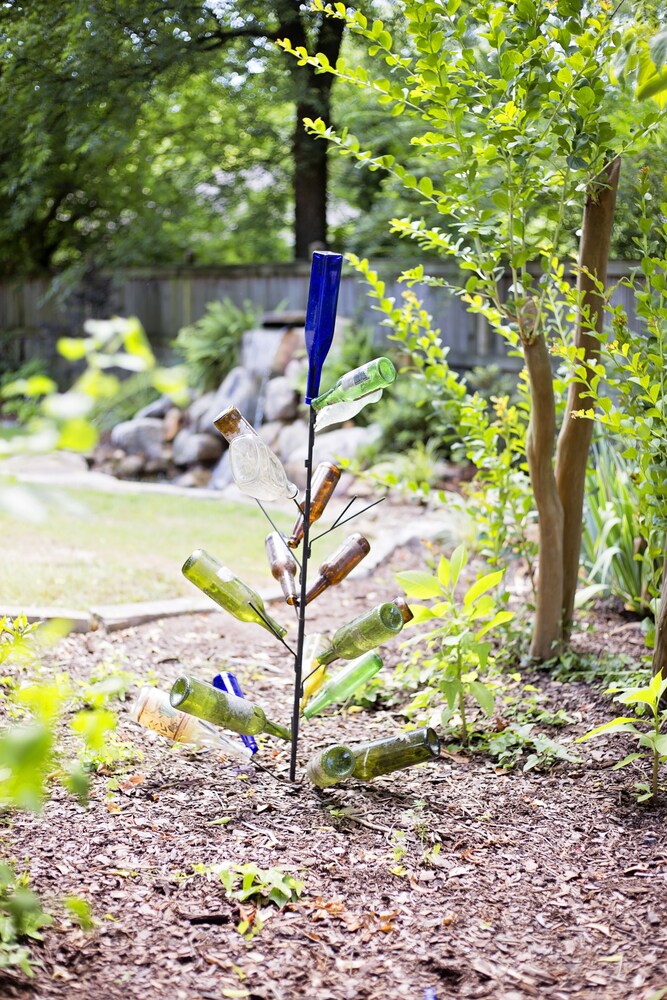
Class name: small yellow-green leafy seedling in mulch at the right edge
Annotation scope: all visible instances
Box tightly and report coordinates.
[579,671,667,802]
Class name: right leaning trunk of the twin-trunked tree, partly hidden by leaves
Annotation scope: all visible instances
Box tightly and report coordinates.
[556,157,621,631]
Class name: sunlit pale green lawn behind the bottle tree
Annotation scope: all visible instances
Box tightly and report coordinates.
[0,483,294,609]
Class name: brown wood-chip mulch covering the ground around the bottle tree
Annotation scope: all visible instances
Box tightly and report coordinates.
[0,548,667,1000]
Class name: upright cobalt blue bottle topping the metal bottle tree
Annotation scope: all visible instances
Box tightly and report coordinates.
[306,250,343,403]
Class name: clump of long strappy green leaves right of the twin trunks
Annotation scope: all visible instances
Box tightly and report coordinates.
[582,437,662,614]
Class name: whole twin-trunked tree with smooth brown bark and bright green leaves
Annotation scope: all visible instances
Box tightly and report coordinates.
[285,0,661,659]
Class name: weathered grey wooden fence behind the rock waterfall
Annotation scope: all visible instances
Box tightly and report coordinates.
[0,261,635,370]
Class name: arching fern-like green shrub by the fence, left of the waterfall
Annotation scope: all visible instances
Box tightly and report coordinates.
[174,298,261,392]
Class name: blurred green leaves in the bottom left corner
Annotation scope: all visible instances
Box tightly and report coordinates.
[0,864,53,976]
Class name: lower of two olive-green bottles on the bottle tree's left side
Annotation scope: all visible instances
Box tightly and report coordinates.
[169,674,292,740]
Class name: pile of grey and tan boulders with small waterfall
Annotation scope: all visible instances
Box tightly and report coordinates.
[95,314,380,490]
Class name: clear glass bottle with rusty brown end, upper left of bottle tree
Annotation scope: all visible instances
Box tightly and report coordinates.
[213,406,299,503]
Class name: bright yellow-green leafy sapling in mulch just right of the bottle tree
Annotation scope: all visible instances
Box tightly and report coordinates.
[395,545,514,744]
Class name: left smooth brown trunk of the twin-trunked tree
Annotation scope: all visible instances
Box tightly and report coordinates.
[523,334,563,660]
